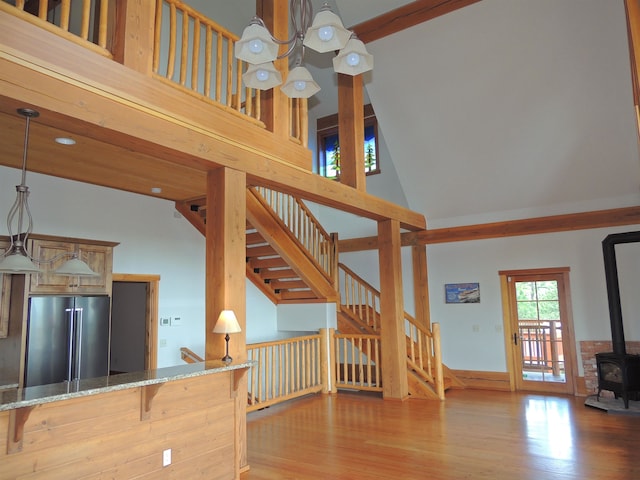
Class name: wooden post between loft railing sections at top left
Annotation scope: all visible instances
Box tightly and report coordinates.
[111,0,159,75]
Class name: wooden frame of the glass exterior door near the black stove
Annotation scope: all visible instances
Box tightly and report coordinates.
[498,267,578,395]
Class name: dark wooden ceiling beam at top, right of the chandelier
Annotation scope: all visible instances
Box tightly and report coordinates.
[350,0,480,43]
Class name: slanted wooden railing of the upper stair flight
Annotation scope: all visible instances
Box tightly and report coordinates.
[251,187,337,281]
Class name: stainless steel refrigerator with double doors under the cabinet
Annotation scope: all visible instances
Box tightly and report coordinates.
[25,295,111,387]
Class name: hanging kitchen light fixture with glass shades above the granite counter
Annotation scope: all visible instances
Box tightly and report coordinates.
[0,108,98,277]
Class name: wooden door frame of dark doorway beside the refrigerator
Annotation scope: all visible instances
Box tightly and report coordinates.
[112,273,160,370]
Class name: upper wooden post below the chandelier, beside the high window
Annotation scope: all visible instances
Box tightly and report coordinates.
[338,73,367,192]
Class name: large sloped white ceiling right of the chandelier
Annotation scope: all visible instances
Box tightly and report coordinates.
[322,0,640,228]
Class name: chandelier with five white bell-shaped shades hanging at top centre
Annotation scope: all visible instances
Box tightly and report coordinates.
[235,0,373,98]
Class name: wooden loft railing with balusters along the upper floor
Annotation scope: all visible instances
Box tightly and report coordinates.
[0,0,308,142]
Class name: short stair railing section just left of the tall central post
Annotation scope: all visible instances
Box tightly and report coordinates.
[338,263,380,331]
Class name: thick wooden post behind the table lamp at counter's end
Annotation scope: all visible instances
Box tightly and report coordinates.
[205,168,247,472]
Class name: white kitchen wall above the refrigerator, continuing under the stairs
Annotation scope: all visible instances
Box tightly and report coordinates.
[0,167,277,367]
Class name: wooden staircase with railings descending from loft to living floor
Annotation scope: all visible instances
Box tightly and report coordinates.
[176,187,464,399]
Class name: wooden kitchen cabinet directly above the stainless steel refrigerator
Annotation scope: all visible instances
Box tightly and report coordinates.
[28,236,117,295]
